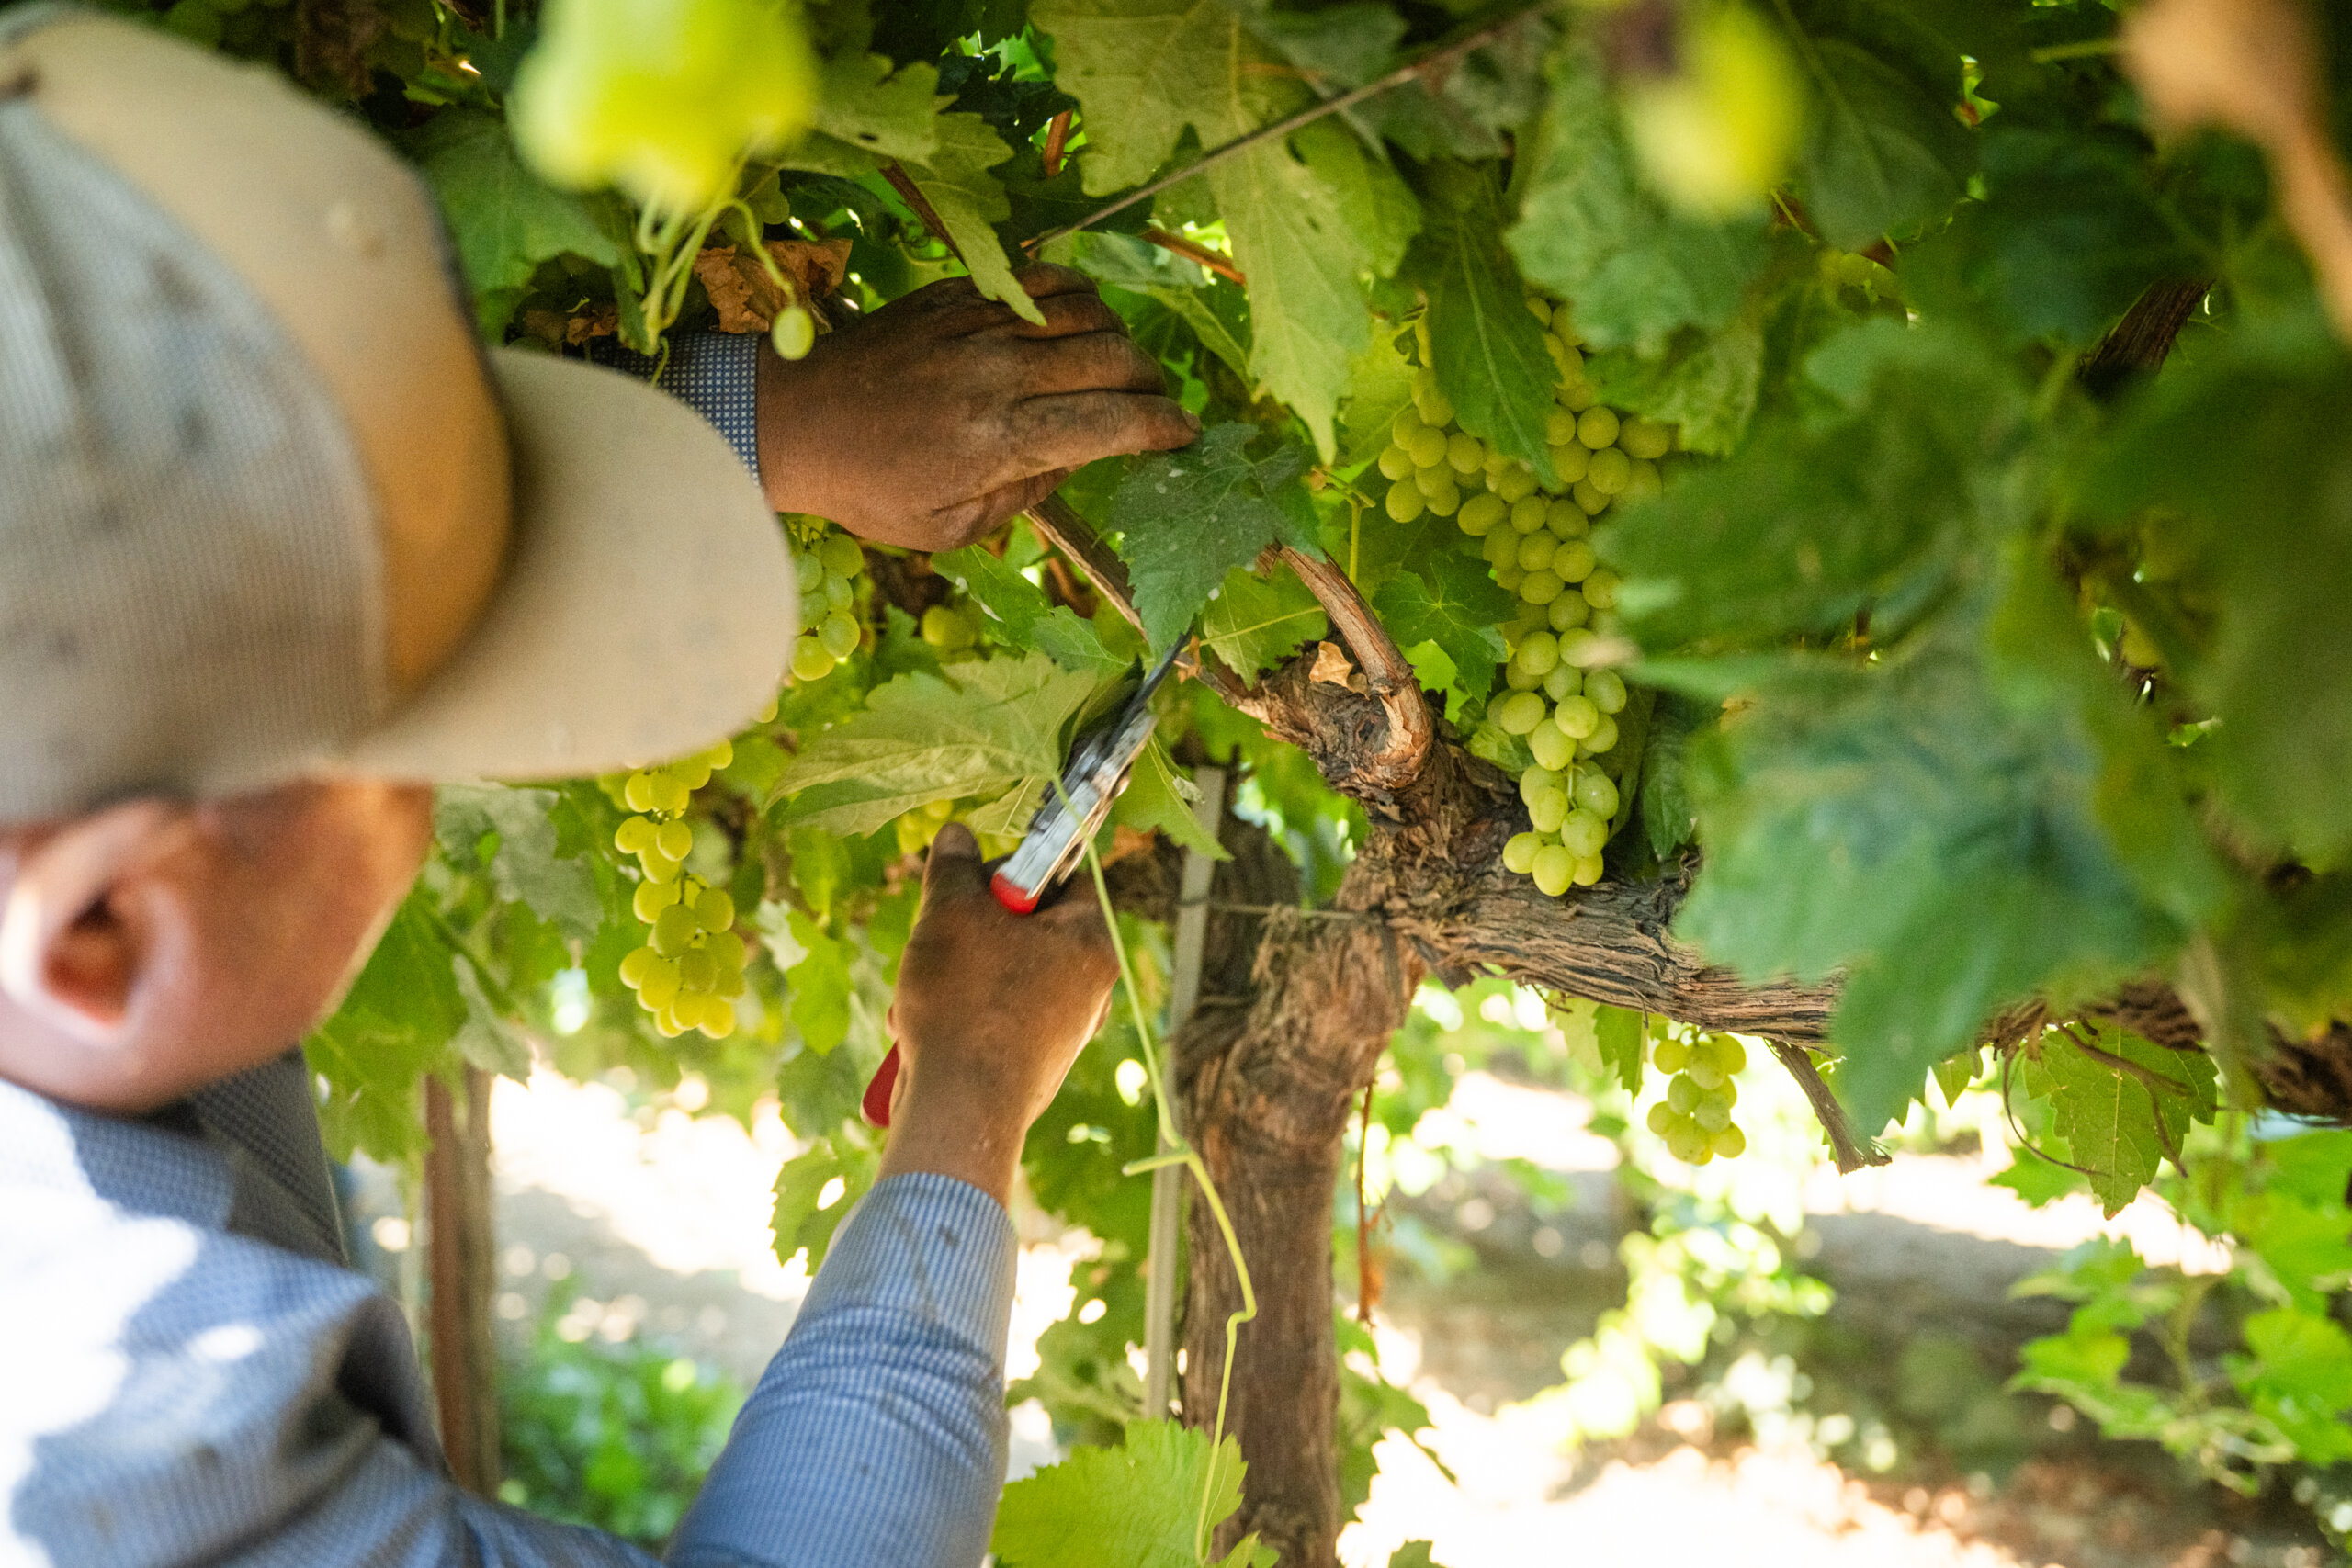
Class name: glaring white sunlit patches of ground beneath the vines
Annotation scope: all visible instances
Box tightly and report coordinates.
[458,1072,2319,1568]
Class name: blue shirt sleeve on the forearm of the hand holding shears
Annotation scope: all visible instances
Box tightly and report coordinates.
[671,1176,1016,1568]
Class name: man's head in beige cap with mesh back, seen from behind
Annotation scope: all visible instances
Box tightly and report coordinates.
[0,17,797,1110]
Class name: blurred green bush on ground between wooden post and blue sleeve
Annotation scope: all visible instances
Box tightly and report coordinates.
[499,1288,743,1551]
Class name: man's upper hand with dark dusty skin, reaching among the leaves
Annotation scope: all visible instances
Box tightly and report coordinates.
[760,265,1200,550]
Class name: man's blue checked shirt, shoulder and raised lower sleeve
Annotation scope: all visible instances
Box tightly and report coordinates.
[0,1054,1013,1568]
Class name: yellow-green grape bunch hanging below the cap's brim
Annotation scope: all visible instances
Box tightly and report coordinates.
[612,747,748,1039]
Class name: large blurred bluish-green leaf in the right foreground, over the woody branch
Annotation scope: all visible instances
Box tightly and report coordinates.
[1665,611,2183,1131]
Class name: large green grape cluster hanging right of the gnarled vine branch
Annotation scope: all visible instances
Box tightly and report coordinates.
[1378,296,1675,898]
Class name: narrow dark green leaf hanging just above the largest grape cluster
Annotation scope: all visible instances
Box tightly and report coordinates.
[1408,164,1559,487]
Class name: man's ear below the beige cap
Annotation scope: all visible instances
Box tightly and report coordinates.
[0,799,184,1046]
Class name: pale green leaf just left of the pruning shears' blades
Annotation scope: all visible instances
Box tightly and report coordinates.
[776,653,1099,832]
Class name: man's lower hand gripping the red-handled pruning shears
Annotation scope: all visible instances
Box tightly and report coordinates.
[882,823,1120,1201]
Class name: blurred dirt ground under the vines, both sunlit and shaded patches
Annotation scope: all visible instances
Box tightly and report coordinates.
[442,1075,2331,1568]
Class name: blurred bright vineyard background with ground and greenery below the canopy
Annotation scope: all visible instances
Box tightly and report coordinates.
[341,983,2352,1568]
